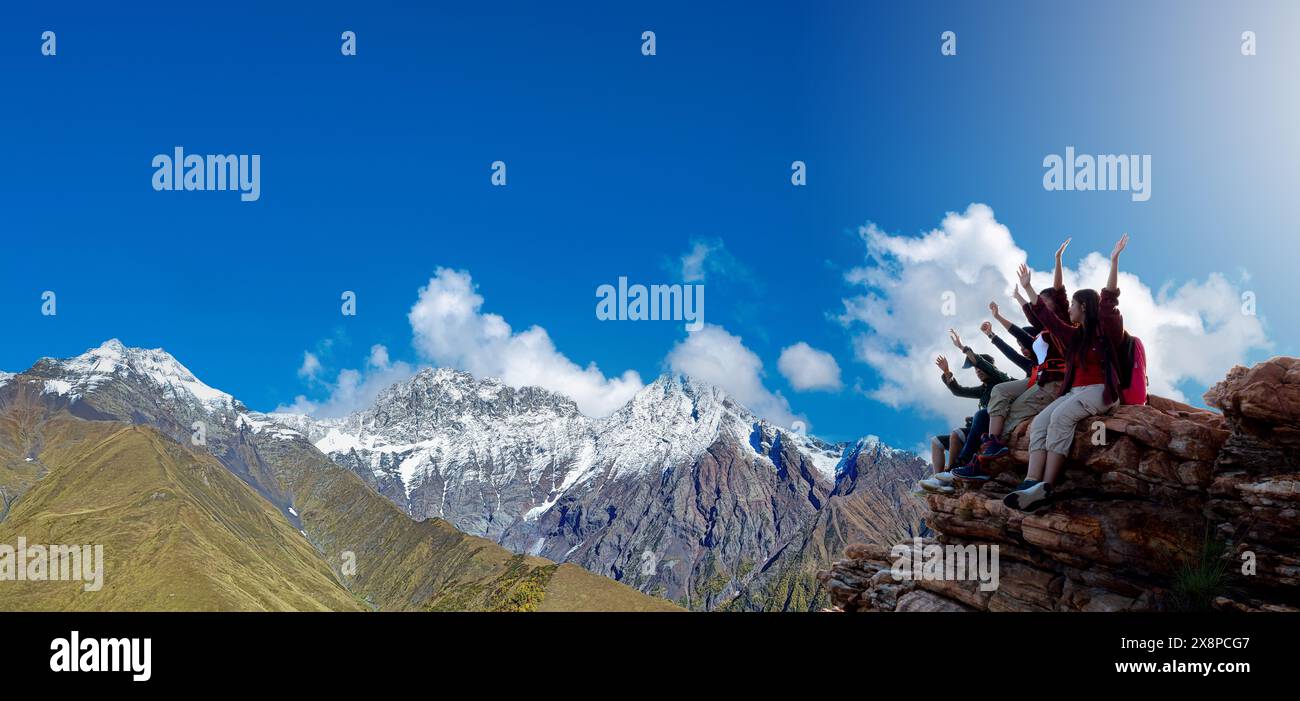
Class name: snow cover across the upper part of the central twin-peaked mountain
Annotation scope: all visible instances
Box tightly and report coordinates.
[269,368,873,528]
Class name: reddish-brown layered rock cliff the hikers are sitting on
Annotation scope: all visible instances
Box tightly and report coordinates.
[819,358,1300,611]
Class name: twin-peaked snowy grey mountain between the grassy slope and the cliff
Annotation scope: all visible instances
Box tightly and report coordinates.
[276,368,920,609]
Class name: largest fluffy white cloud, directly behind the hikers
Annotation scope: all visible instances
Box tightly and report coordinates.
[840,204,1269,424]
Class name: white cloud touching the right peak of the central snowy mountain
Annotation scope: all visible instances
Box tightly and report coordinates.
[667,324,797,427]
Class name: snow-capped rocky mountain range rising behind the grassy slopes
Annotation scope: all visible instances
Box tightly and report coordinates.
[0,339,919,607]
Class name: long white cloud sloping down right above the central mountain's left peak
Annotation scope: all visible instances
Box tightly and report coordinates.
[407,268,644,416]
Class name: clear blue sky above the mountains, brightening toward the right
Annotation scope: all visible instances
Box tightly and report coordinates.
[0,1,1300,447]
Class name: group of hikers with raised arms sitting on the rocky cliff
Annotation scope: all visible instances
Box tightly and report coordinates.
[919,234,1147,511]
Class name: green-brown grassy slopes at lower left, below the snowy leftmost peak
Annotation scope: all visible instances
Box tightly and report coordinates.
[0,385,680,611]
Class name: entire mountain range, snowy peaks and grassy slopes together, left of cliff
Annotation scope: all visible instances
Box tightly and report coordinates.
[0,339,927,611]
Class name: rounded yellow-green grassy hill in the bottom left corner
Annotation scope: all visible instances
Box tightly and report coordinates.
[0,415,361,611]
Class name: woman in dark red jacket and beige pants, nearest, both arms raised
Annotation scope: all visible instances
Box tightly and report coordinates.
[1005,234,1128,511]
